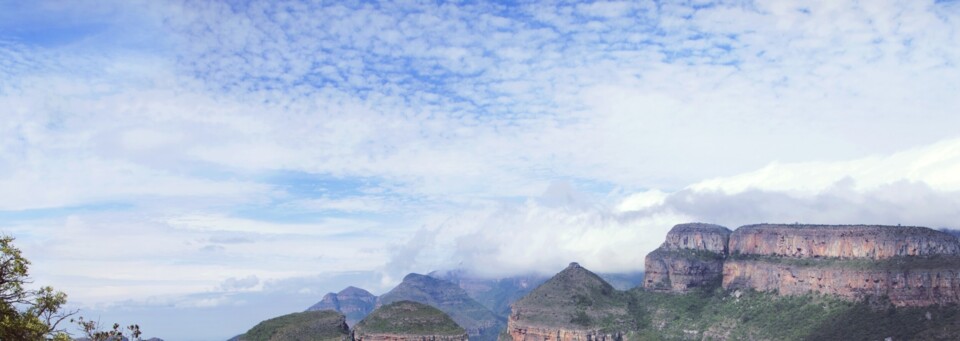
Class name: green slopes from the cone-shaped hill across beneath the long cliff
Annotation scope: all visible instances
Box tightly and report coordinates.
[510,264,960,340]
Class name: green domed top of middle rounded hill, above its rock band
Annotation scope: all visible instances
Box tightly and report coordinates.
[356,301,466,336]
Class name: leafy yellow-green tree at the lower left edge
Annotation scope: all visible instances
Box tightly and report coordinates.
[0,236,76,340]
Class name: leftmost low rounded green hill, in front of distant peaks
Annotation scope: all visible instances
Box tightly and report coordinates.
[238,310,350,341]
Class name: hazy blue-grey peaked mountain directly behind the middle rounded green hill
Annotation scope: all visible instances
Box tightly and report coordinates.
[377,274,505,340]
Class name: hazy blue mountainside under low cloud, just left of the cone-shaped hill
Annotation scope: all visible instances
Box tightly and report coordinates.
[428,270,549,320]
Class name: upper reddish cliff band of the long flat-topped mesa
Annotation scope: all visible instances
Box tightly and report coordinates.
[730,224,960,259]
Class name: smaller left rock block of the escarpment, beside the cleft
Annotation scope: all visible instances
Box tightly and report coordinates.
[643,223,730,293]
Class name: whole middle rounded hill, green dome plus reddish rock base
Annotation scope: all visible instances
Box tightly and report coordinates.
[353,301,467,341]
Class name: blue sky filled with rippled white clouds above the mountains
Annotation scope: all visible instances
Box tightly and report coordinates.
[0,0,960,341]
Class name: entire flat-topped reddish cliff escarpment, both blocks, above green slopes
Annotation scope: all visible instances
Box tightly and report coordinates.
[644,224,960,306]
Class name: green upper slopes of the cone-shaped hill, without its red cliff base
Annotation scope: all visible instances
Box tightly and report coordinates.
[513,263,633,331]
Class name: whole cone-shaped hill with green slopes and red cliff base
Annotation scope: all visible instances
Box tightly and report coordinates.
[507,263,633,341]
